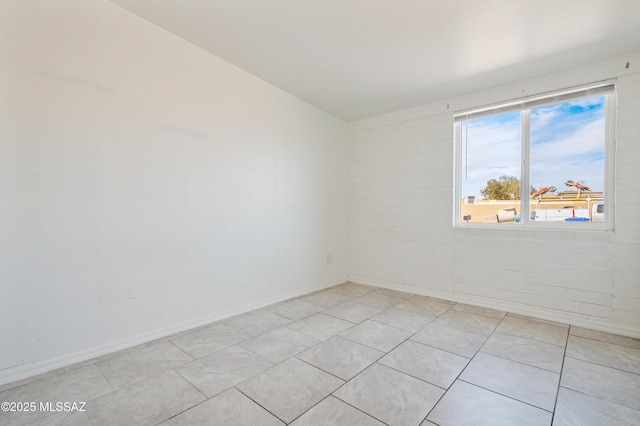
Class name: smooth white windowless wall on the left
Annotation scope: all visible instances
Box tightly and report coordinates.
[0,0,347,383]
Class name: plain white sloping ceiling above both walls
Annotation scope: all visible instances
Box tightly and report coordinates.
[111,0,640,122]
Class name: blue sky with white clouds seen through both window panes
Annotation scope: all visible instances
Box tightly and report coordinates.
[461,96,605,199]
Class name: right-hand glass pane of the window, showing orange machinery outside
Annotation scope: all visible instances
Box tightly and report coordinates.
[530,96,605,222]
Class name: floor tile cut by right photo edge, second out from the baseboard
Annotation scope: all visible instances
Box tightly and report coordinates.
[566,336,640,374]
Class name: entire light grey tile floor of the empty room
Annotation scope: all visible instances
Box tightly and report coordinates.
[0,283,640,426]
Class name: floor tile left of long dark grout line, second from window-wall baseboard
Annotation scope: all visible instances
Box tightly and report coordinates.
[481,332,564,373]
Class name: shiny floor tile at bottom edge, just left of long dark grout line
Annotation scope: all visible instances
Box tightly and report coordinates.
[427,380,551,426]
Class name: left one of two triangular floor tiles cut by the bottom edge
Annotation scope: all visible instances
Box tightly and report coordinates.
[162,388,284,426]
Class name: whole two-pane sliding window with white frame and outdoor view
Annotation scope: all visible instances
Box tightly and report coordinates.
[455,82,615,229]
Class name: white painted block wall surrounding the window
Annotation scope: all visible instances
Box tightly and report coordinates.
[349,52,640,337]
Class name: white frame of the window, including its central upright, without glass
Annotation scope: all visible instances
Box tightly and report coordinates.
[453,80,616,231]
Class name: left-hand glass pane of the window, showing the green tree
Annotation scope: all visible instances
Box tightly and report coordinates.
[460,112,522,223]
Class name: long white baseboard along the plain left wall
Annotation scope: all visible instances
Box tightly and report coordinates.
[0,275,347,390]
